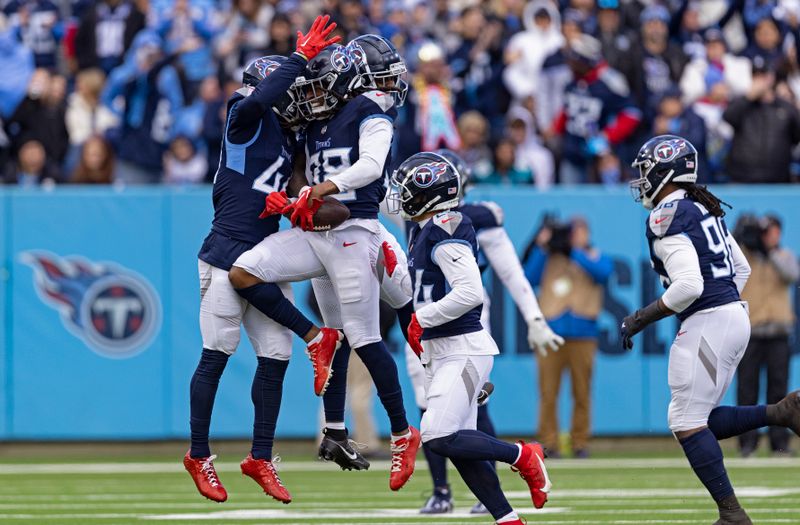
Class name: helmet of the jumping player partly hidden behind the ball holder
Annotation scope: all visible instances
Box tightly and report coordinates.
[347,35,408,107]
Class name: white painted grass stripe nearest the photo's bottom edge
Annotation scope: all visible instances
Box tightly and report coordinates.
[140,507,570,521]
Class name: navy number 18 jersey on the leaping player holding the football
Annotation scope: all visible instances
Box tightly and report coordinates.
[305,91,397,219]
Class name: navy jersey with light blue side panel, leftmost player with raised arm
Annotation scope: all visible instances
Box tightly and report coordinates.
[200,55,306,270]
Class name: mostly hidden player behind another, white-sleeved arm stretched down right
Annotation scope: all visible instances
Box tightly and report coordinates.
[398,149,564,514]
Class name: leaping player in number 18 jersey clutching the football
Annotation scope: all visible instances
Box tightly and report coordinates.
[230,37,420,490]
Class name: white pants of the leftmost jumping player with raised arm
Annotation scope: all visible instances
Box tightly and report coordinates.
[197,260,294,361]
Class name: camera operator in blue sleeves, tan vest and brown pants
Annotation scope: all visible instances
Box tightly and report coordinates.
[524,215,613,458]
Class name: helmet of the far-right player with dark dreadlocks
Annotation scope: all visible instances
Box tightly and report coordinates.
[630,135,697,210]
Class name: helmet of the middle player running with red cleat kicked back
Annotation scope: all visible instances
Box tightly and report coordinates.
[389,151,461,220]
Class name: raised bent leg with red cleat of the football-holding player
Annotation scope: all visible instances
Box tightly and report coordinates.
[229,228,341,395]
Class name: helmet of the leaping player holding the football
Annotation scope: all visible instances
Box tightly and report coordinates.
[292,44,356,120]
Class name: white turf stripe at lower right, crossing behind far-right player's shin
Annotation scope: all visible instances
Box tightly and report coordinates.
[505,487,800,499]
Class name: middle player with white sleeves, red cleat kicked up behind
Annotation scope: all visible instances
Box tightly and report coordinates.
[392,153,550,525]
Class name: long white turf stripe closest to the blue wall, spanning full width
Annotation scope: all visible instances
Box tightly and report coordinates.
[0,458,800,475]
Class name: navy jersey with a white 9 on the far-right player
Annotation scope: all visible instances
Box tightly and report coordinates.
[647,194,739,321]
